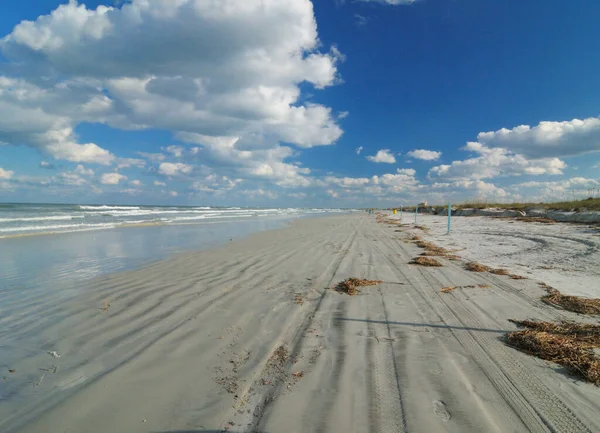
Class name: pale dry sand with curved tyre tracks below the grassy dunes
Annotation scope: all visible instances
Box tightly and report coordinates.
[408,215,600,298]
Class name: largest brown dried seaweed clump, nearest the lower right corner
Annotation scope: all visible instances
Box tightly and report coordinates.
[506,320,600,386]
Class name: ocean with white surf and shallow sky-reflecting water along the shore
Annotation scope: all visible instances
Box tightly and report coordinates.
[0,204,347,296]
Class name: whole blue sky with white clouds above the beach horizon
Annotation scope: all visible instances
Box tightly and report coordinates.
[0,0,600,207]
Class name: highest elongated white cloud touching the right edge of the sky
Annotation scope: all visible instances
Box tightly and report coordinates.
[477,117,600,158]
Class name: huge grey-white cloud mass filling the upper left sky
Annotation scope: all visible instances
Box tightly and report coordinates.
[0,0,344,164]
